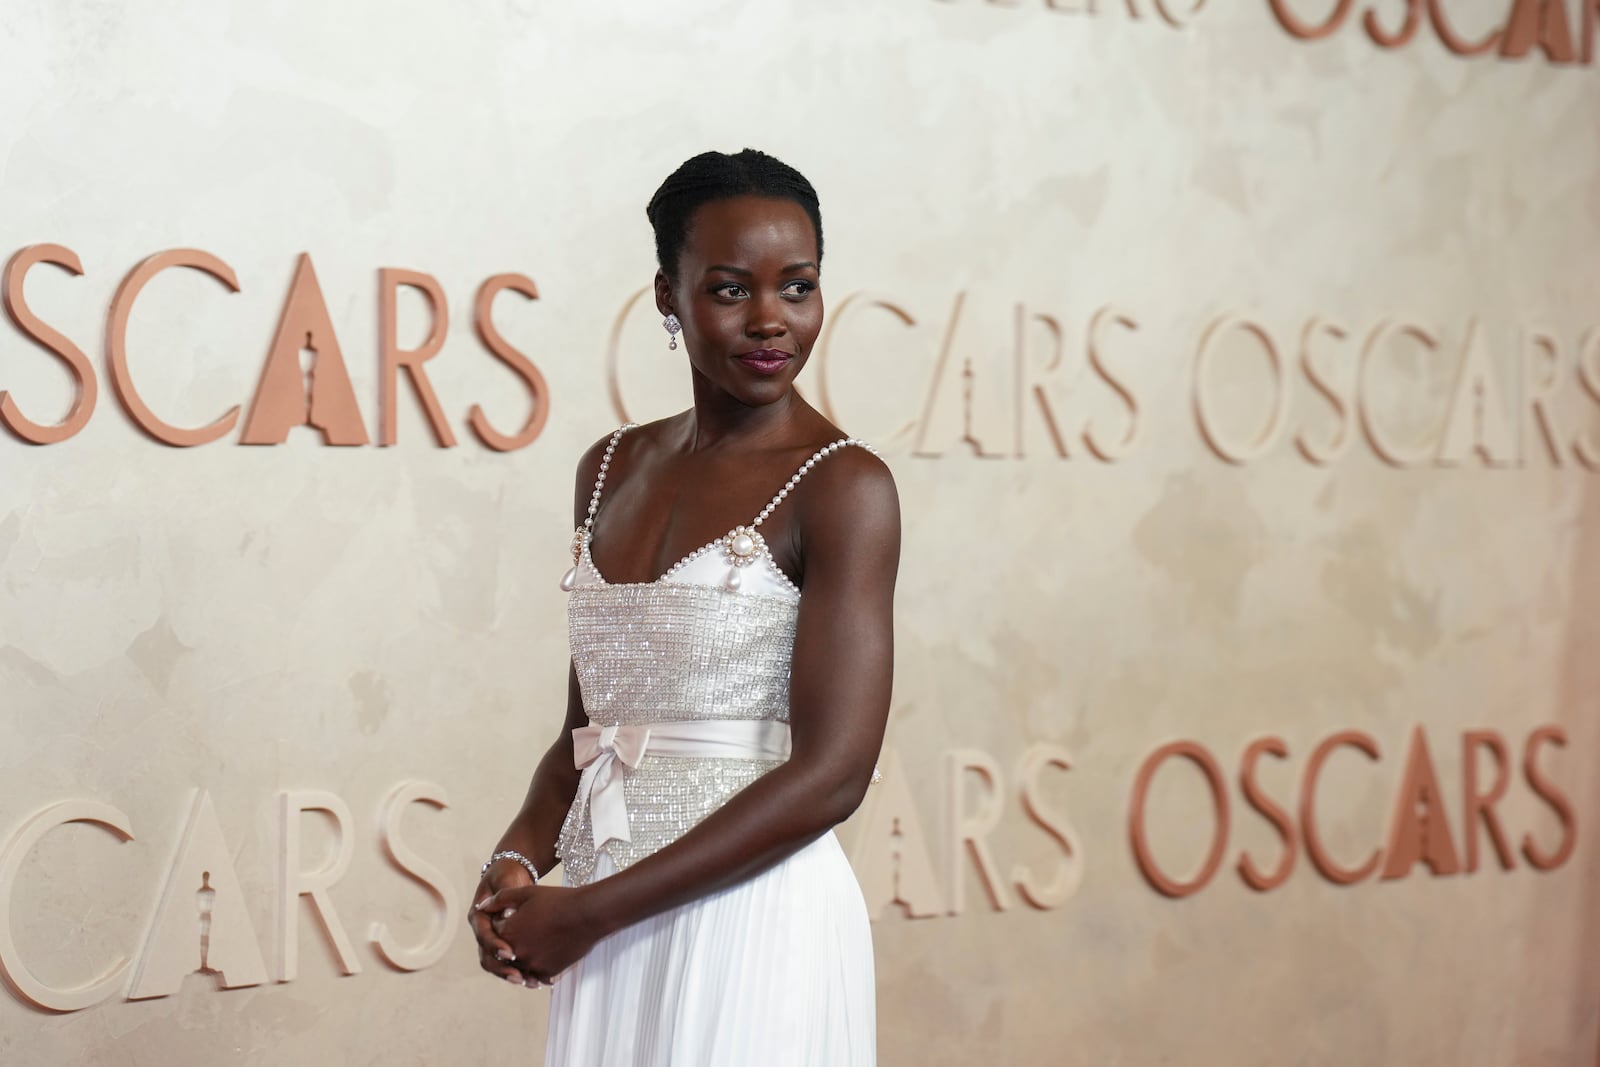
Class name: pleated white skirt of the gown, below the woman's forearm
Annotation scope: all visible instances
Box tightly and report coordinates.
[544,833,877,1067]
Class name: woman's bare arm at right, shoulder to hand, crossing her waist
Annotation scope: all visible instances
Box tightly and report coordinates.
[483,448,901,981]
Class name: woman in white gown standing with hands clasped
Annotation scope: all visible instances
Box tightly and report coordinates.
[470,149,899,1067]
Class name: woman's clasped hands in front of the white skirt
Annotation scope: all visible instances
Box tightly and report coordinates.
[467,864,600,989]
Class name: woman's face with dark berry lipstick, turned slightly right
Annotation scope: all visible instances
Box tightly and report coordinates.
[656,197,822,406]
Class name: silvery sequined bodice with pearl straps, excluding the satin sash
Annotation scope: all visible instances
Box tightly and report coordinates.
[557,427,859,885]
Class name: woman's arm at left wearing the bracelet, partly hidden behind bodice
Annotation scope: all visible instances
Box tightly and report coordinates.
[467,437,610,985]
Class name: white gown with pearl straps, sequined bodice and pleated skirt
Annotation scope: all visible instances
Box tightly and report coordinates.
[546,427,877,1067]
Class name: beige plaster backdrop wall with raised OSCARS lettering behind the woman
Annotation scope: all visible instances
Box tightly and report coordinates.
[0,0,1600,1067]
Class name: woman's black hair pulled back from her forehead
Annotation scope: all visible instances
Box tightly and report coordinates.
[645,149,822,278]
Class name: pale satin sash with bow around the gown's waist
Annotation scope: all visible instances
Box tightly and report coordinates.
[573,718,789,851]
